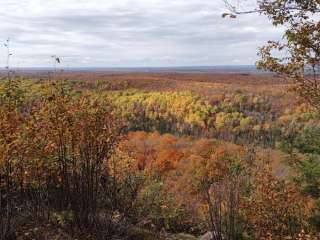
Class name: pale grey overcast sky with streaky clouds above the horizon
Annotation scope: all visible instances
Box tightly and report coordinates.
[0,0,281,67]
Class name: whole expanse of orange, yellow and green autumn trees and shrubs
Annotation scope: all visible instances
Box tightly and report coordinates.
[0,0,320,240]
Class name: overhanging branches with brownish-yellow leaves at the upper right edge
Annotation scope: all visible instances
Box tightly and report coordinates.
[254,0,320,108]
